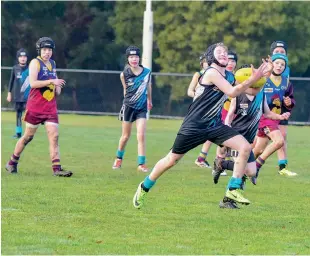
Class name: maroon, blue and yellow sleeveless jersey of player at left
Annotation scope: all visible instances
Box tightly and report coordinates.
[26,57,57,114]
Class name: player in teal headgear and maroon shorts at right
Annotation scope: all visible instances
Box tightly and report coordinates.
[252,53,297,184]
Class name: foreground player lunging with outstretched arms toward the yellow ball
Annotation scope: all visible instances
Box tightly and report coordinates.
[133,43,269,209]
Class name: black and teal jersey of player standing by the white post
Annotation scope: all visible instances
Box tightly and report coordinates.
[123,65,151,110]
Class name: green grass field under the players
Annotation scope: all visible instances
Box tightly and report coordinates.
[1,113,310,255]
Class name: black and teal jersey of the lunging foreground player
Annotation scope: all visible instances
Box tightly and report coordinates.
[179,67,235,135]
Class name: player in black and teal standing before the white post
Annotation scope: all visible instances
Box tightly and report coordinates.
[112,46,153,172]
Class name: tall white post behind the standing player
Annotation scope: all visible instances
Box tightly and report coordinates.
[142,0,153,119]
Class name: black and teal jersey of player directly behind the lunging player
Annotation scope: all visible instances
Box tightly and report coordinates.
[231,90,265,143]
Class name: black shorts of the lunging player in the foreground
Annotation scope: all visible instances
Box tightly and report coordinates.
[172,124,240,154]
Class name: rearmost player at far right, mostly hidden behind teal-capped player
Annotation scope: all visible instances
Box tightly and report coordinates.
[270,41,295,174]
